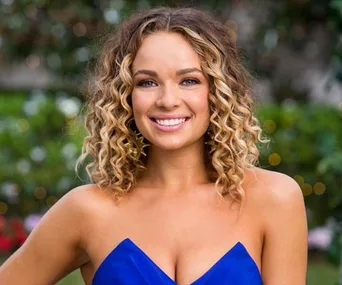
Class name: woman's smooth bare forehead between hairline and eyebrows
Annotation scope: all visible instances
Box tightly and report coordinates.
[133,32,201,71]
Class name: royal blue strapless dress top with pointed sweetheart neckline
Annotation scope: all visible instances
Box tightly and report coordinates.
[92,238,262,285]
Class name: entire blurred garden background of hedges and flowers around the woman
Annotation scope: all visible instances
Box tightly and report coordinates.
[0,0,342,285]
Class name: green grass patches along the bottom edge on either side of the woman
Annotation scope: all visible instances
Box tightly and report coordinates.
[57,261,338,285]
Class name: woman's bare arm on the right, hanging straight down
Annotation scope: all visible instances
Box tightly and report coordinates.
[262,173,307,285]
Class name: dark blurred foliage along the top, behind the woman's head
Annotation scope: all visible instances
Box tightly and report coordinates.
[0,0,342,91]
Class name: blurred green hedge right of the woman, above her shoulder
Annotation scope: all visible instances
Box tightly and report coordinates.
[259,101,342,227]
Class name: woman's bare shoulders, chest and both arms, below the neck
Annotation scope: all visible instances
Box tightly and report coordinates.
[0,168,307,285]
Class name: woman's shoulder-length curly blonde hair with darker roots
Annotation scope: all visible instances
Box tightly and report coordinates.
[78,8,265,202]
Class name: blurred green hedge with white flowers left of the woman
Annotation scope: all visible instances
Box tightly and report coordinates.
[0,90,84,216]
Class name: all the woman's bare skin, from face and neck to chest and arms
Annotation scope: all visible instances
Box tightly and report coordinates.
[0,33,307,285]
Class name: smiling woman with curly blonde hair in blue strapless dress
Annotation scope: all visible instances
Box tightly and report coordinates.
[0,8,307,285]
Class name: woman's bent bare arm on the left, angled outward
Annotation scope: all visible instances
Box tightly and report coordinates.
[0,187,88,285]
